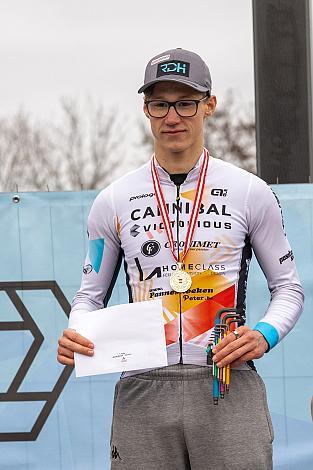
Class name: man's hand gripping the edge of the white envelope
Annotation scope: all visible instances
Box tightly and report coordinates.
[57,328,94,366]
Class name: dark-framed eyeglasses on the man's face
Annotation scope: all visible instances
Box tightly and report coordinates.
[145,96,209,118]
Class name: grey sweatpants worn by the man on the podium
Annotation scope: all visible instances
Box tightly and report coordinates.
[111,364,273,470]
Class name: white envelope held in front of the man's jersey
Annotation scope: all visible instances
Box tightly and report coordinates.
[72,300,168,377]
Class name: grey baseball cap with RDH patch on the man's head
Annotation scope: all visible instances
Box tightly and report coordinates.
[138,48,212,94]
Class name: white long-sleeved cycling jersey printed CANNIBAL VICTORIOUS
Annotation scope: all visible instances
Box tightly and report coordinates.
[70,154,303,365]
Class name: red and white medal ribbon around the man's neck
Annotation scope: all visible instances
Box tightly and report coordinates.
[151,149,209,264]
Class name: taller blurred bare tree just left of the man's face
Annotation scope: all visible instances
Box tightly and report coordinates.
[54,99,127,189]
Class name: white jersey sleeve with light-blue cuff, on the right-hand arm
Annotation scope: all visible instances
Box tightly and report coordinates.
[247,176,304,348]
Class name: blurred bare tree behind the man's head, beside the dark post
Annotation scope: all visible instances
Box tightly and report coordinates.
[139,91,256,173]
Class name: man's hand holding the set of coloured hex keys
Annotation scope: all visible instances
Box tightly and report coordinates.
[213,326,268,367]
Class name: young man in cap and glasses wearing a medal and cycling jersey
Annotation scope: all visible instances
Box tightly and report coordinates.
[58,49,303,470]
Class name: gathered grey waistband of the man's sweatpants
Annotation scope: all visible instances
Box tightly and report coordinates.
[128,364,212,380]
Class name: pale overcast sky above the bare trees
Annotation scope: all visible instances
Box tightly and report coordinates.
[0,0,254,119]
